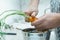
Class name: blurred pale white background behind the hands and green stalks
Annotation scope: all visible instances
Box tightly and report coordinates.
[0,0,56,40]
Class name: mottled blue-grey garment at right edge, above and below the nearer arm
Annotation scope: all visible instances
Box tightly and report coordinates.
[50,0,60,40]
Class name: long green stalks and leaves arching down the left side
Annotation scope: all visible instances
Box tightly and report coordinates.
[0,10,28,40]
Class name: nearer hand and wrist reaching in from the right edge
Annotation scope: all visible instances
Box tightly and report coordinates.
[32,13,60,31]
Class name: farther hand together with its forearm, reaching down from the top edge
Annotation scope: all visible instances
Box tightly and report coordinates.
[25,0,39,16]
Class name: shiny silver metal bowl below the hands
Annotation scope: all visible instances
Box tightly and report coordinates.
[23,28,48,40]
